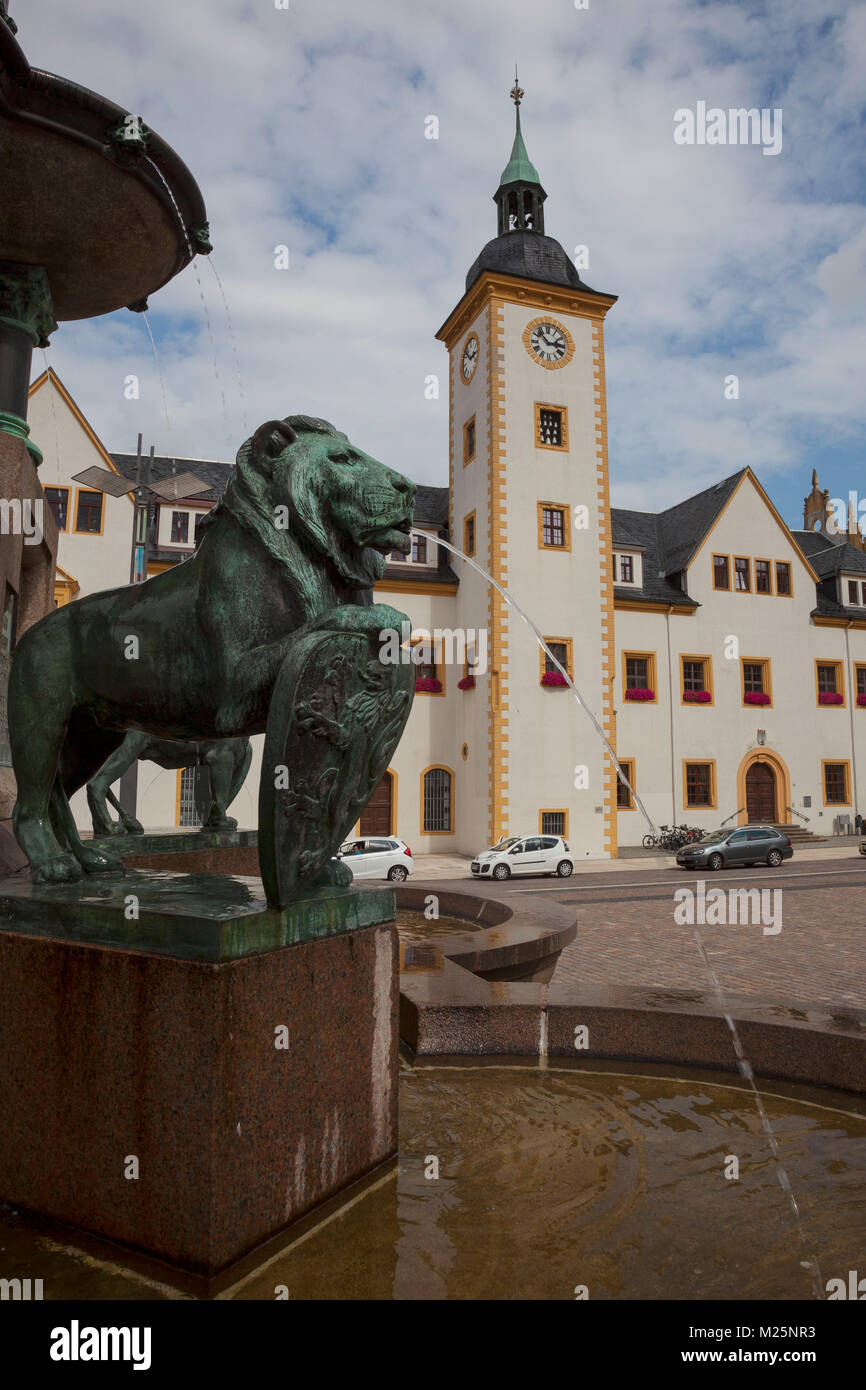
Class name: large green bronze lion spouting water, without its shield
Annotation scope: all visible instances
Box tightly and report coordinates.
[8,416,414,883]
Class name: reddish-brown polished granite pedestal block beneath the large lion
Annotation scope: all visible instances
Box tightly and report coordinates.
[0,883,398,1277]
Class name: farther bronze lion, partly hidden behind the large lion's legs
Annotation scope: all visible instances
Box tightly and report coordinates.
[88,728,253,835]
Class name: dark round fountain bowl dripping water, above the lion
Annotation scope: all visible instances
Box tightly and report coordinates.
[0,22,210,321]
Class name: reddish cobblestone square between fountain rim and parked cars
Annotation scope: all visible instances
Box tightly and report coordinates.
[414,852,866,1008]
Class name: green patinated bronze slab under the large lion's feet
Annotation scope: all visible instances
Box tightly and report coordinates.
[0,870,396,963]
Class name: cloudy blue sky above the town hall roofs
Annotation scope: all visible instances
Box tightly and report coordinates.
[11,0,866,524]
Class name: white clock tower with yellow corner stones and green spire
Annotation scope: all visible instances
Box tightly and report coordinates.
[436,79,616,859]
